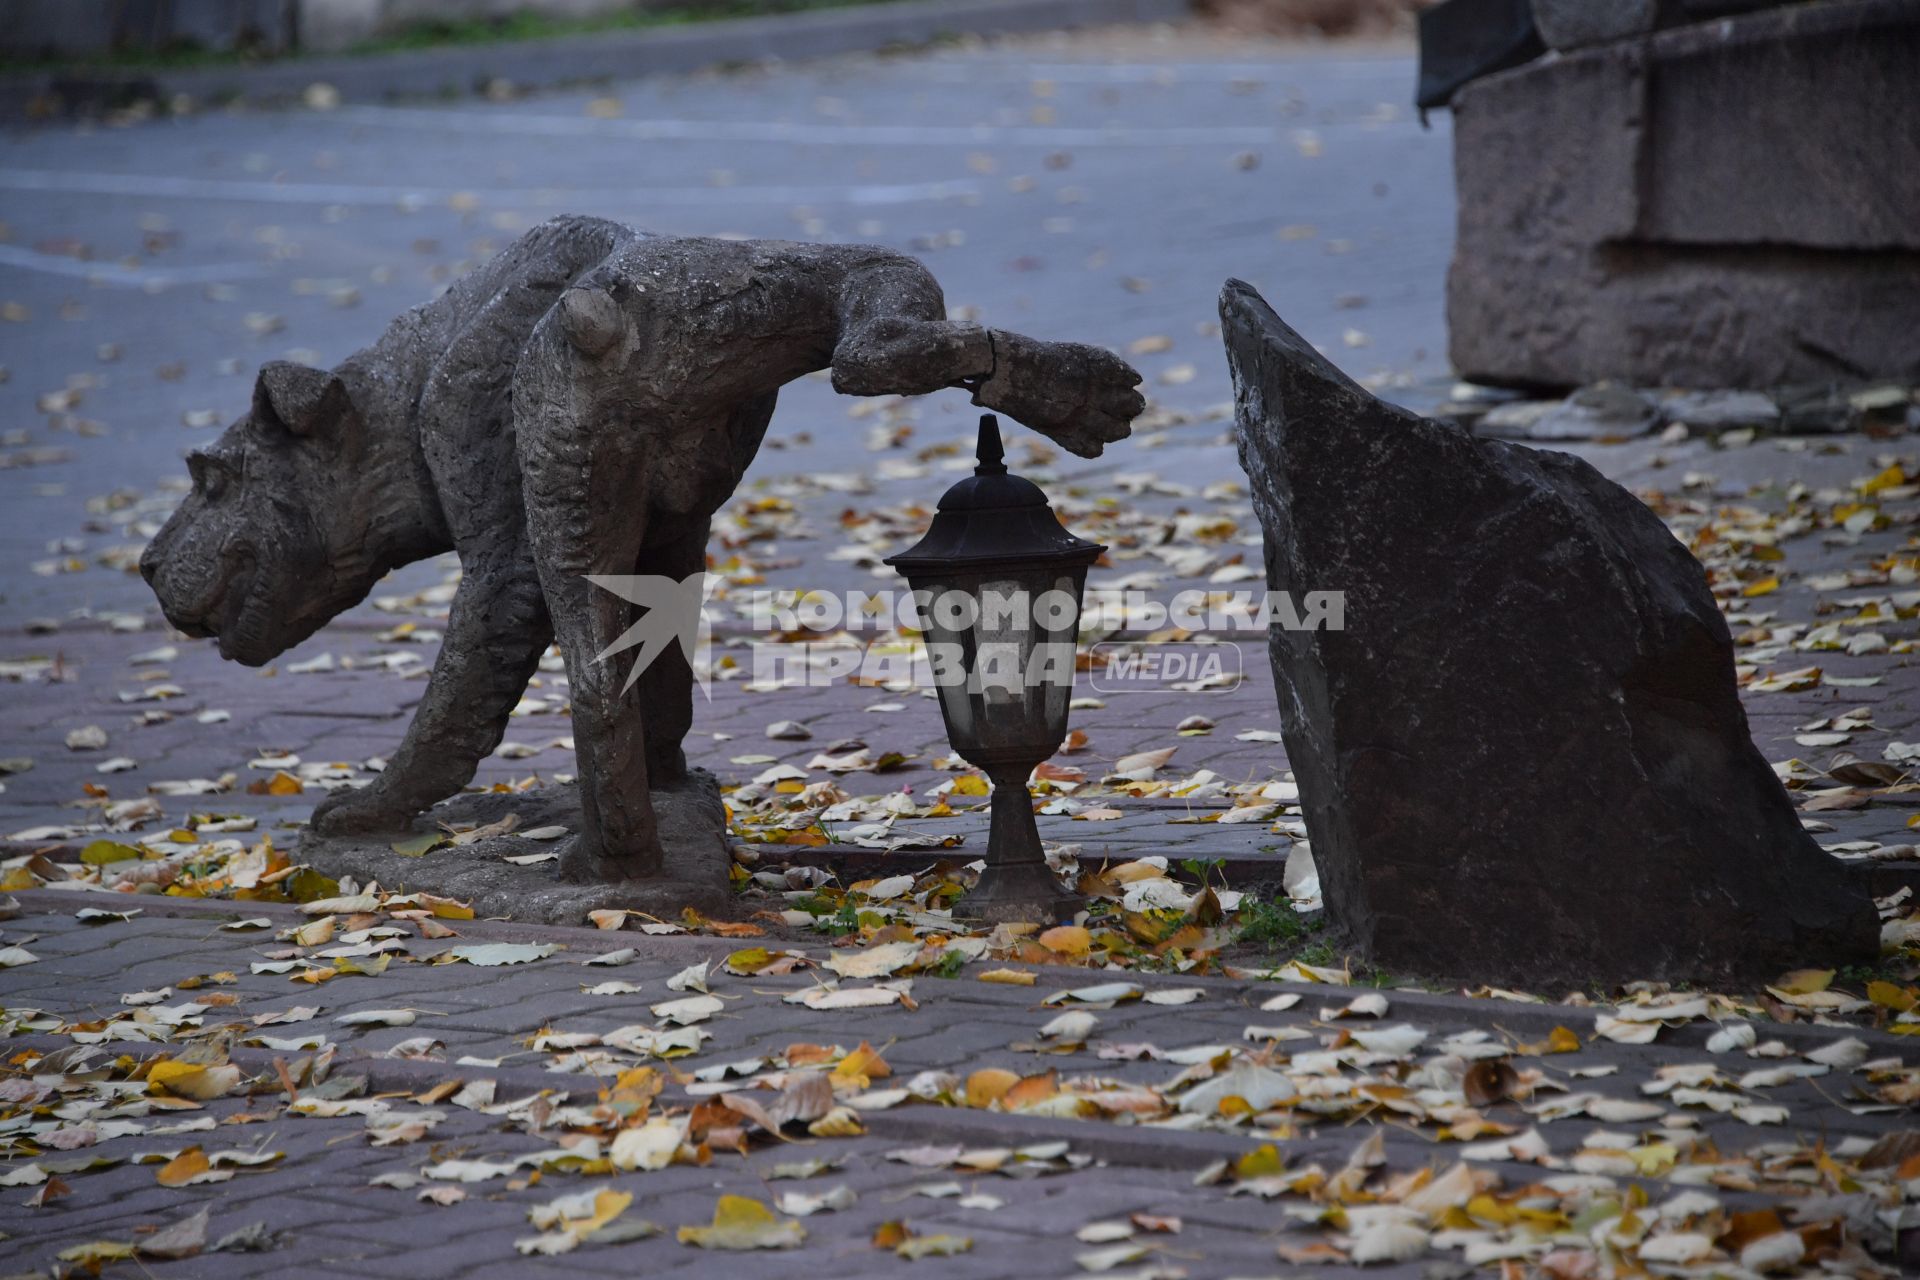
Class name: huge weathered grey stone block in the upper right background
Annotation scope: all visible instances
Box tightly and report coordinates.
[1448,0,1920,388]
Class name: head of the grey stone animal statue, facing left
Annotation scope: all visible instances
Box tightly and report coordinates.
[140,361,384,666]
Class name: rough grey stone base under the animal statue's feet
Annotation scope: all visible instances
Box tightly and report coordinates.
[296,770,732,925]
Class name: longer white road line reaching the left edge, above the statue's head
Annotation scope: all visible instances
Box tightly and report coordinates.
[0,169,979,209]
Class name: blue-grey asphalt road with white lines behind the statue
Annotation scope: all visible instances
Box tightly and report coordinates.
[0,33,1452,629]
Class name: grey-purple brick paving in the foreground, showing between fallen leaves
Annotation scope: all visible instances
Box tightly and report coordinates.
[0,890,1910,1278]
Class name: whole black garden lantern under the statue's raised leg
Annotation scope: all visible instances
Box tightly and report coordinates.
[887,413,1106,923]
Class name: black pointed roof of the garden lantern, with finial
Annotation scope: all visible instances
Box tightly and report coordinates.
[885,413,1106,578]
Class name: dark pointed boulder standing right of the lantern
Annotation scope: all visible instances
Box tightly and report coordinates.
[1221,282,1878,984]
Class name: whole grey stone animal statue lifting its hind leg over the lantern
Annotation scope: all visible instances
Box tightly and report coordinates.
[140,217,1142,881]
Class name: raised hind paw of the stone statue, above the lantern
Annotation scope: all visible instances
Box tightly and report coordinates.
[973,330,1146,459]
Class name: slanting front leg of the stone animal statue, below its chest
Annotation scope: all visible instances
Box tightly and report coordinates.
[313,547,553,835]
